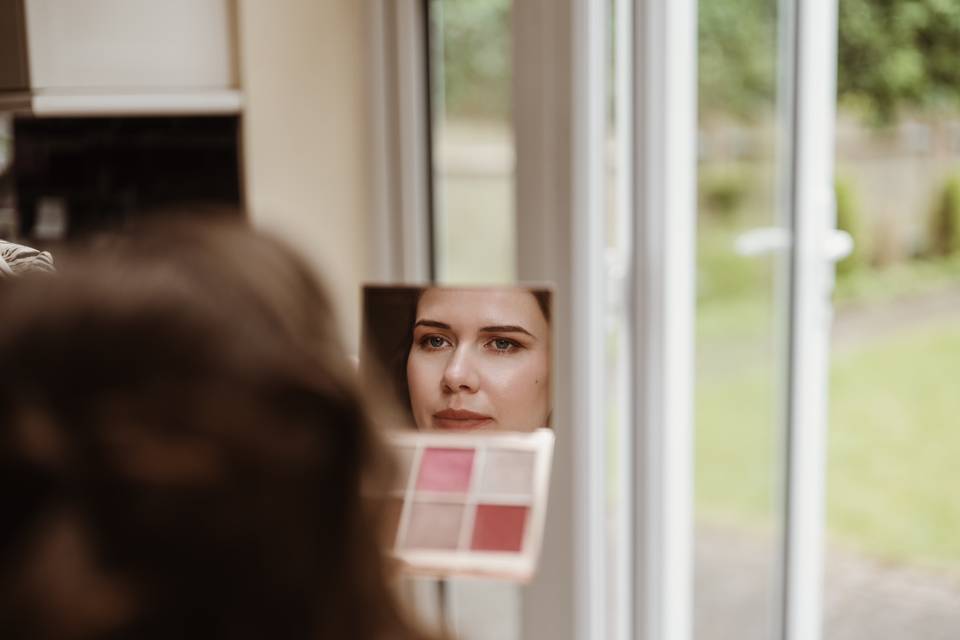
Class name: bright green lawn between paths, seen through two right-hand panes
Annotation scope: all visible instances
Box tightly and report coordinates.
[696,288,960,570]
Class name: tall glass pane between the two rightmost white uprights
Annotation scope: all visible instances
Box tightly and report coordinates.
[694,0,788,640]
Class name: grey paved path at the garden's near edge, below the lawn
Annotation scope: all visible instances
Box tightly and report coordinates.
[694,523,960,640]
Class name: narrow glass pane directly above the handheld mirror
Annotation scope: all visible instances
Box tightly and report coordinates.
[430,0,516,283]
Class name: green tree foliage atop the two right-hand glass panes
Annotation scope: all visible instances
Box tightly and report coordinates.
[699,0,960,125]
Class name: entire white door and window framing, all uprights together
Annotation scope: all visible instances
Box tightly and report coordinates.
[368,0,836,640]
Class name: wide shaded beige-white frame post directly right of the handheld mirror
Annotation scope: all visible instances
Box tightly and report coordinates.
[512,0,608,640]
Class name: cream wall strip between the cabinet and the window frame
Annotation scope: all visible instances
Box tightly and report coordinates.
[237,0,373,349]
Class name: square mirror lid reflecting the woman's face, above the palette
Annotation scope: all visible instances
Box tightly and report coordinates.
[361,286,552,432]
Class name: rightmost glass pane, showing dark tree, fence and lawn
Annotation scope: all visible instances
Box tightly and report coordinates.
[825,1,960,640]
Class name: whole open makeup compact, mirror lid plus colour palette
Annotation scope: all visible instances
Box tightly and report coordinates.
[361,286,554,582]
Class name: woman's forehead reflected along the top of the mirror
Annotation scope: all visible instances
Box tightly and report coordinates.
[417,287,546,331]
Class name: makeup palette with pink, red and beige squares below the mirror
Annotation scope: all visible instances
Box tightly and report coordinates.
[388,429,553,582]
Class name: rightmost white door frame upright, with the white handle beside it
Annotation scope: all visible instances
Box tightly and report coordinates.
[779,0,840,640]
